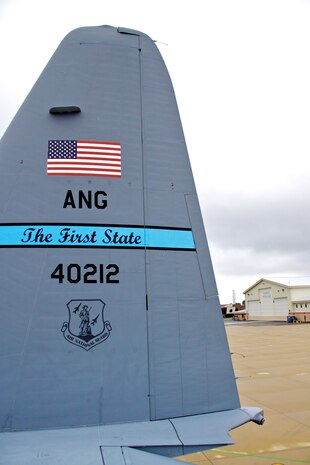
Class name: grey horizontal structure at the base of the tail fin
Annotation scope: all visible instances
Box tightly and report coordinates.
[0,407,263,465]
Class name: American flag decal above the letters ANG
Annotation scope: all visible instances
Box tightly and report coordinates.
[47,140,122,178]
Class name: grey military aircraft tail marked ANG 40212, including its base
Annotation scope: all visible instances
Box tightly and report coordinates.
[0,26,264,465]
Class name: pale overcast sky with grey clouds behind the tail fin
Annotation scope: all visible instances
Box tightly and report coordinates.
[0,0,310,303]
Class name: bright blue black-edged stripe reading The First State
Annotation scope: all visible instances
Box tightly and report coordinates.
[0,224,195,250]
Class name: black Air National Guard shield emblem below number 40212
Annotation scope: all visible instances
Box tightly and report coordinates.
[61,299,112,350]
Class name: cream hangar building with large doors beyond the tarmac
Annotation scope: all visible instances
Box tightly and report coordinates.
[244,278,310,322]
